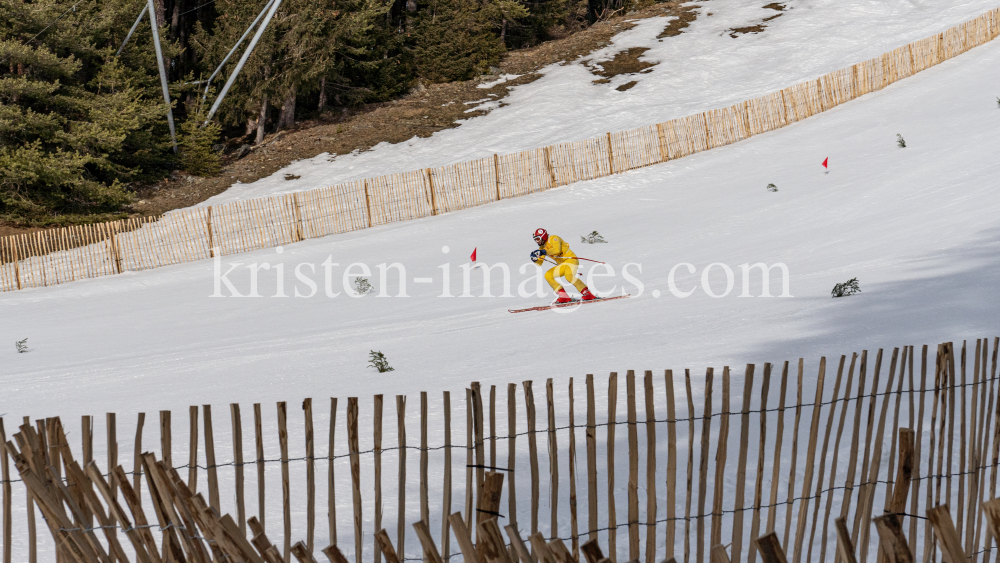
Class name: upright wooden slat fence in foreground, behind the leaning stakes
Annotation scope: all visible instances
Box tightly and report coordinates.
[0,338,1000,563]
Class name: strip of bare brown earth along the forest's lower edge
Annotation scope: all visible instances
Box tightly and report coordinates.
[0,2,699,235]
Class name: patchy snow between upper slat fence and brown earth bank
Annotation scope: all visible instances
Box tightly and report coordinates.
[200,0,996,205]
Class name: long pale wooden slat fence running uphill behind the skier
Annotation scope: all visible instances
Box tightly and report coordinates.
[0,8,1000,291]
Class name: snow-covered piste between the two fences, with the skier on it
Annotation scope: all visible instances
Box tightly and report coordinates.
[0,34,1000,416]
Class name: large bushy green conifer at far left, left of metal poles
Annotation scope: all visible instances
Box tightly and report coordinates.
[0,0,169,224]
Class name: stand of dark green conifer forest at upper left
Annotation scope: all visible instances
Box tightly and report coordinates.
[0,0,616,225]
